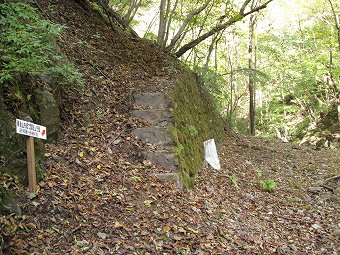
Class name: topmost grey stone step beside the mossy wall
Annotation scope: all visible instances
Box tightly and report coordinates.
[133,92,171,109]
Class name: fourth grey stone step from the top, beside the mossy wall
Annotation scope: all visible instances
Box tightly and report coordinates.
[145,151,178,170]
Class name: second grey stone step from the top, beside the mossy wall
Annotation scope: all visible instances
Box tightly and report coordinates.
[132,109,173,127]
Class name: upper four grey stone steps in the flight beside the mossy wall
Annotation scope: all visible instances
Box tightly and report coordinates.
[132,92,178,171]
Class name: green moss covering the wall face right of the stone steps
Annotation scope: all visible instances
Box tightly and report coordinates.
[169,72,224,188]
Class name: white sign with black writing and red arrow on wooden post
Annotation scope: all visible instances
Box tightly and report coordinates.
[16,117,47,192]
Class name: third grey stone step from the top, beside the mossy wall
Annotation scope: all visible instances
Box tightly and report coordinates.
[132,127,173,146]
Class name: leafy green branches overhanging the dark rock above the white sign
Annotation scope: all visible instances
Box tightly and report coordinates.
[0,3,82,85]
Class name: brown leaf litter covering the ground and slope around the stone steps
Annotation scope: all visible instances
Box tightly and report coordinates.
[0,0,340,254]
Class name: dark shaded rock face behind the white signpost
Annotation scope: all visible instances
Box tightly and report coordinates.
[0,79,61,214]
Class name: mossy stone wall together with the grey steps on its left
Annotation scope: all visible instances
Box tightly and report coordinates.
[132,71,224,188]
